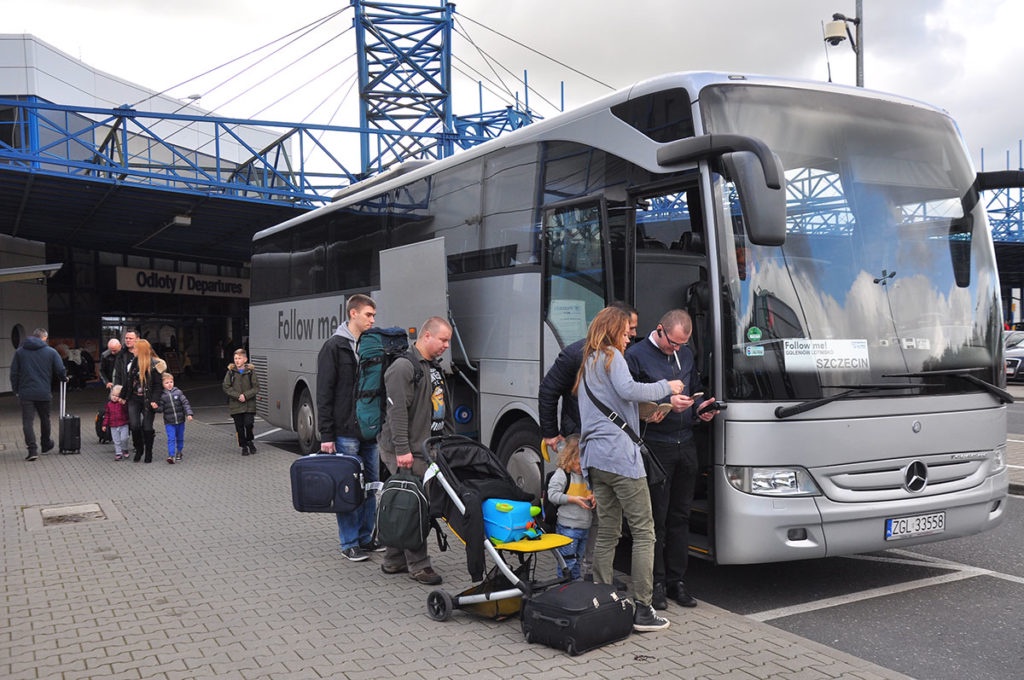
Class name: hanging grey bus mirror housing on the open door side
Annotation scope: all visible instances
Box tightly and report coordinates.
[721,152,785,246]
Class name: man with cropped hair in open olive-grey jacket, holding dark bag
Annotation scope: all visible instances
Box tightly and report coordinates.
[377,316,455,586]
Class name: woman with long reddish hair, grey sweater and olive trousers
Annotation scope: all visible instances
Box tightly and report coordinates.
[573,307,683,632]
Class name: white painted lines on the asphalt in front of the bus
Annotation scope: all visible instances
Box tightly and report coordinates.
[746,549,1024,622]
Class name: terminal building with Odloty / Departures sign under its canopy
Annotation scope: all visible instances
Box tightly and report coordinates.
[0,35,306,391]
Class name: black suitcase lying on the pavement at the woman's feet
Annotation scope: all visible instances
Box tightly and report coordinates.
[520,581,636,656]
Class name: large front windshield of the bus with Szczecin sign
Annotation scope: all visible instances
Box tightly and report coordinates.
[701,85,1002,399]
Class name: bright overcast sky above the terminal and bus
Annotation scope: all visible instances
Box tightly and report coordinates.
[4,0,1024,170]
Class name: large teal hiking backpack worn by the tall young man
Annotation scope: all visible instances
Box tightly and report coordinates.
[355,327,423,441]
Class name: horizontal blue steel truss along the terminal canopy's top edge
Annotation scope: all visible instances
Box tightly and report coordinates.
[0,97,434,208]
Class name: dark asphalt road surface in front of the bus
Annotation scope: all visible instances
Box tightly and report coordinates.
[687,497,1024,680]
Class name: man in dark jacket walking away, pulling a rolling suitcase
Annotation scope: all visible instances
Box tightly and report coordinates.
[10,328,68,461]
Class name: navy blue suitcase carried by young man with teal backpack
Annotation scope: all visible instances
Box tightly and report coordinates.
[291,454,365,512]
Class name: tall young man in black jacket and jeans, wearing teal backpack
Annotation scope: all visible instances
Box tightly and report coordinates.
[316,294,381,562]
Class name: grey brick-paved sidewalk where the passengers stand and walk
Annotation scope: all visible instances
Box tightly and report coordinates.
[0,383,1007,680]
